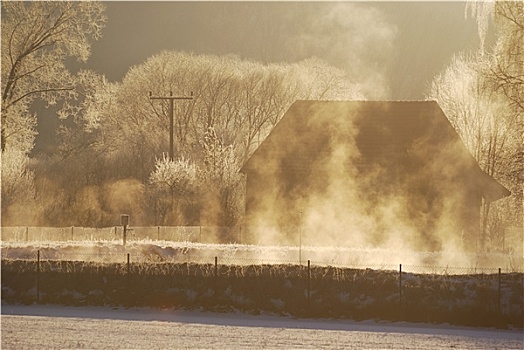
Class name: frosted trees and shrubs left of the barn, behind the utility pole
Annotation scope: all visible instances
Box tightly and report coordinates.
[2,51,361,226]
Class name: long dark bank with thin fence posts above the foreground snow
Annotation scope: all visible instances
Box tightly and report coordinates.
[2,250,524,327]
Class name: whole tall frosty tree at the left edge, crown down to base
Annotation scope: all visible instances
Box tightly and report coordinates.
[1,1,105,224]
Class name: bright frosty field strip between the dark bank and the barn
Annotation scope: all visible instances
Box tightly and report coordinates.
[2,240,524,274]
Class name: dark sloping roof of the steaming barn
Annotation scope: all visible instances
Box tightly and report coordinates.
[240,101,510,201]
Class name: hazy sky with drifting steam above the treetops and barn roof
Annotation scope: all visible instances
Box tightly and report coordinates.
[87,1,479,100]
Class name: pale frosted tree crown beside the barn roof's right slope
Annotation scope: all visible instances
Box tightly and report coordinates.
[429,54,518,169]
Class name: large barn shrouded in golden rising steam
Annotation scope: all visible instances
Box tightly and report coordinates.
[240,101,510,250]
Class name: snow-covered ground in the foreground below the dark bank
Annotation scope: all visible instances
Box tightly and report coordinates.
[1,305,524,350]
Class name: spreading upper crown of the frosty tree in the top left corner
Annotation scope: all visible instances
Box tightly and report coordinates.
[1,1,105,151]
